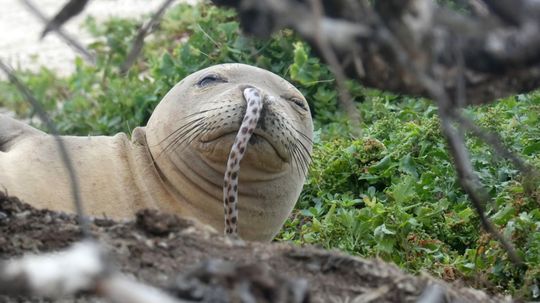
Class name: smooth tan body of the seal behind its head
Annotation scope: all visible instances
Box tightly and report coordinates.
[0,123,173,218]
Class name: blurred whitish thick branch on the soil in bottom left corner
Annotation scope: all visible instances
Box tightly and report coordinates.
[0,241,187,303]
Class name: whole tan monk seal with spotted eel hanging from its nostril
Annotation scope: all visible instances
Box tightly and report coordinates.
[0,64,313,241]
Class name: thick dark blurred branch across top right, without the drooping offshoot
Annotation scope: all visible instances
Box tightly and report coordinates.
[213,0,540,104]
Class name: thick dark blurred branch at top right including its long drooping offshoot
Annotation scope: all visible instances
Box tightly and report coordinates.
[214,0,540,264]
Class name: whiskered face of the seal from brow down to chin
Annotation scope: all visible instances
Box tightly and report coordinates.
[162,64,312,174]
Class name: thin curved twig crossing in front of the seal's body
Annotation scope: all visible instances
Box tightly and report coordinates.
[0,60,90,237]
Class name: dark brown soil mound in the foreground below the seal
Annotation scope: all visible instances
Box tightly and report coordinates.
[0,194,509,302]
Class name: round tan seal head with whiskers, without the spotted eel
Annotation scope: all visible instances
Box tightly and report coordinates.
[146,64,313,240]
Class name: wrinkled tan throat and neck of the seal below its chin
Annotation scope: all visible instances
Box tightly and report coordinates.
[132,128,303,241]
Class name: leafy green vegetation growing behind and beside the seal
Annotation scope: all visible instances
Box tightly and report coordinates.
[0,5,540,298]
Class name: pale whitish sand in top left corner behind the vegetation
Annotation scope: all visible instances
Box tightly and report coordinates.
[0,0,196,77]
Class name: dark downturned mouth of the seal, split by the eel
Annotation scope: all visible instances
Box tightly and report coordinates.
[199,128,290,163]
